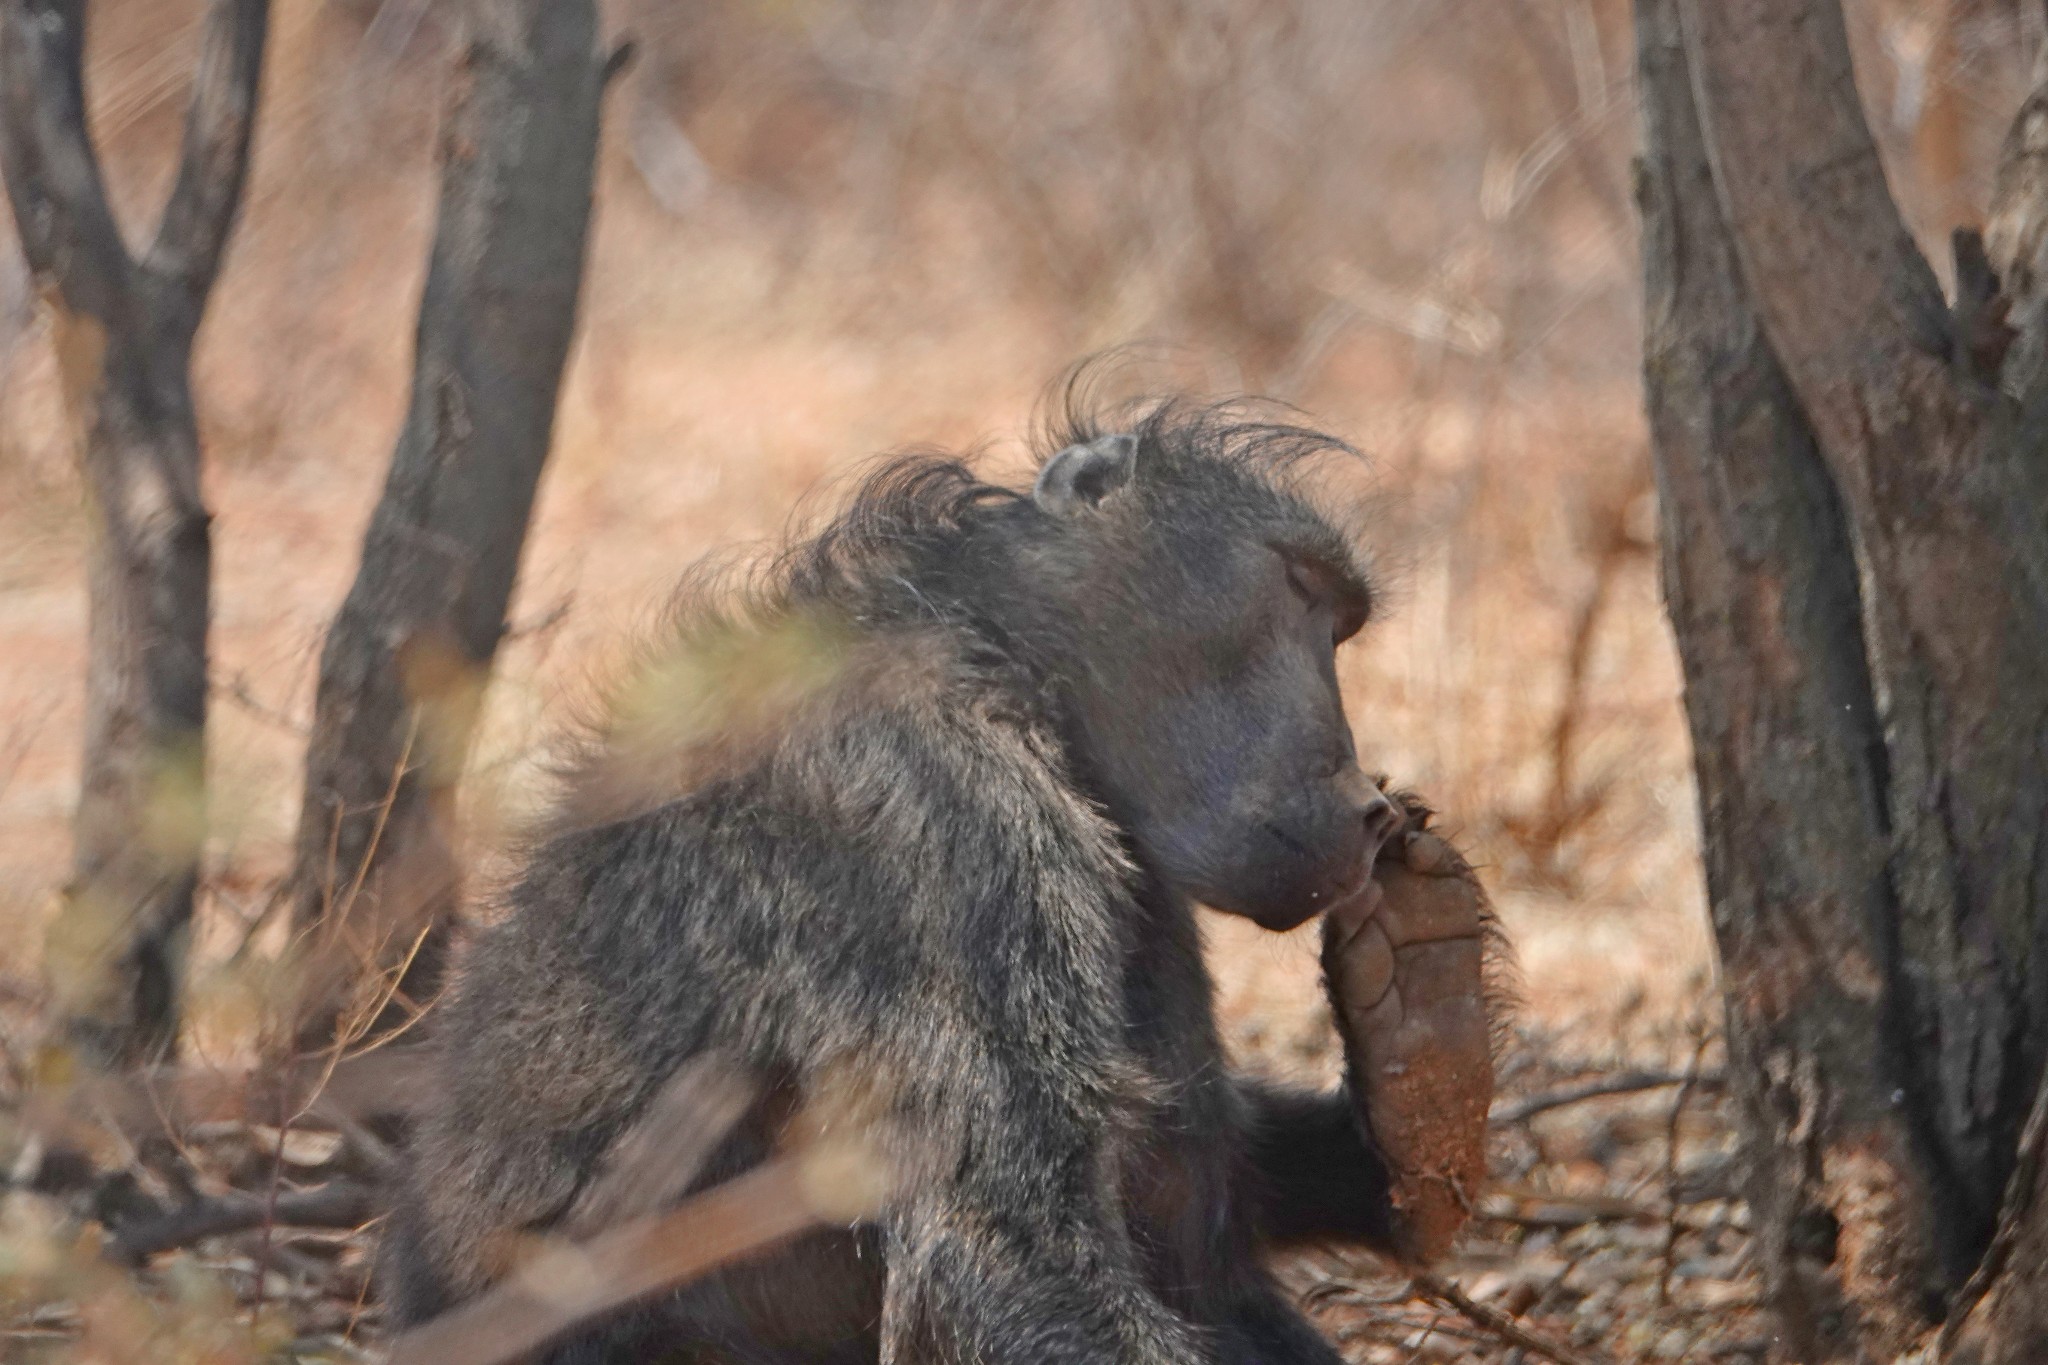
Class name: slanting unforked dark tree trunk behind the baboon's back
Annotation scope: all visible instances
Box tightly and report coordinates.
[291,0,606,1038]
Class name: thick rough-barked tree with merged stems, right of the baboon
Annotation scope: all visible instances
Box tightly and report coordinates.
[1636,0,2048,1361]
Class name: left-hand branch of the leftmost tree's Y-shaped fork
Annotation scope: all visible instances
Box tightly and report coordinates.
[0,0,135,325]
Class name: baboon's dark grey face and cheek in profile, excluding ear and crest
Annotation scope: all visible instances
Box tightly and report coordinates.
[1019,444,1399,931]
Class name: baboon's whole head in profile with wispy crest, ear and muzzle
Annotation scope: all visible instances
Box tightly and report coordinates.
[1018,409,1399,929]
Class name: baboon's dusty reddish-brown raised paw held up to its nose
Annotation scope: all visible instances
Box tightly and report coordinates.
[1323,792,1493,1265]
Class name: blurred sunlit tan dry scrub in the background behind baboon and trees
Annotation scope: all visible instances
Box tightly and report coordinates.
[0,0,2038,1359]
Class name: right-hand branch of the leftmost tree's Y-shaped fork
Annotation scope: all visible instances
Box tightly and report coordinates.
[145,0,270,315]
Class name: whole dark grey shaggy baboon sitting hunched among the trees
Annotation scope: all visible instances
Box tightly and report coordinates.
[385,392,1491,1365]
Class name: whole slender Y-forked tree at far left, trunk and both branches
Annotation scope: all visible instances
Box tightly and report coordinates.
[0,0,270,1064]
